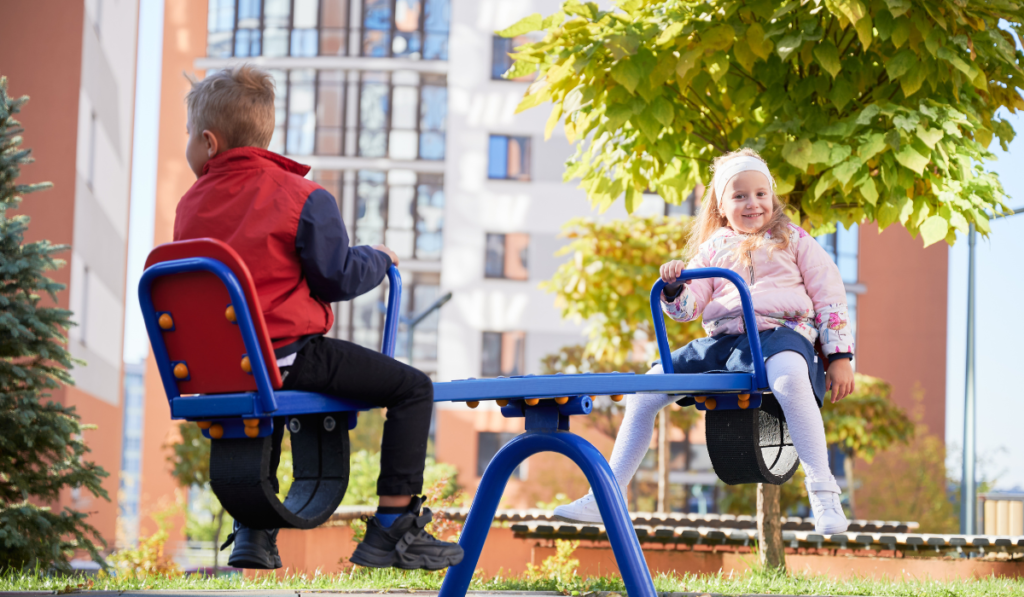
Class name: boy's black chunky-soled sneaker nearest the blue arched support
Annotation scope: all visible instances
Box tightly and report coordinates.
[349,497,463,570]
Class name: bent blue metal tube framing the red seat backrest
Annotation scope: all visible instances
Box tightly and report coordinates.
[138,257,278,416]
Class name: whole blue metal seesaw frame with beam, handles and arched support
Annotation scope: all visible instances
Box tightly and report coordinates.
[139,257,768,597]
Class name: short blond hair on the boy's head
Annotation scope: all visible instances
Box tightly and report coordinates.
[185,65,273,150]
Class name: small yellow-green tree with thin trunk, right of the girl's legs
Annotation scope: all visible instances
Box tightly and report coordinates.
[821,373,914,517]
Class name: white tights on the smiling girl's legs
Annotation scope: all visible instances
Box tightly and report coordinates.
[610,350,831,487]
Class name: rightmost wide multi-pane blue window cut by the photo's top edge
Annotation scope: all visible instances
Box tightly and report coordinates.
[362,0,451,60]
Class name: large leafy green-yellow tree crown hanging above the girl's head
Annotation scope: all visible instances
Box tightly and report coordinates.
[500,0,1024,246]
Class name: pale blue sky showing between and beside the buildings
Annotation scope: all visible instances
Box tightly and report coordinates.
[124,8,1024,491]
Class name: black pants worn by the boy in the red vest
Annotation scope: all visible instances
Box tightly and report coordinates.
[270,337,434,496]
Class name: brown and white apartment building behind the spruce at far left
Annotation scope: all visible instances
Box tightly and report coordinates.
[0,0,138,547]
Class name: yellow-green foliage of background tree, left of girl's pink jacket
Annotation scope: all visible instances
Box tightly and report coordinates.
[543,216,703,364]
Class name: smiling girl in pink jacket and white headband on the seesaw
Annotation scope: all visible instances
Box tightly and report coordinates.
[555,148,853,534]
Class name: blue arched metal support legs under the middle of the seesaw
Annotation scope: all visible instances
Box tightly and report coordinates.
[438,431,657,597]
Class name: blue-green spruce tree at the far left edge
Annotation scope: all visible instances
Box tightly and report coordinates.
[0,77,109,570]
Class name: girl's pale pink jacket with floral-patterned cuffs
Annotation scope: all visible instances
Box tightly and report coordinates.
[662,224,853,355]
